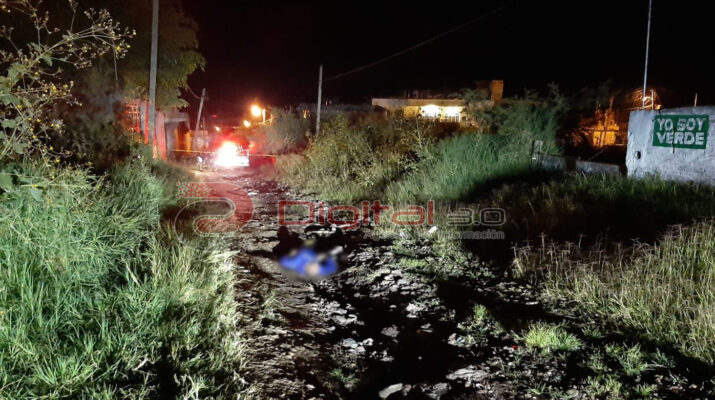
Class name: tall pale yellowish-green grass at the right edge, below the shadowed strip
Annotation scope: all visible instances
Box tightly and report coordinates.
[515,220,715,363]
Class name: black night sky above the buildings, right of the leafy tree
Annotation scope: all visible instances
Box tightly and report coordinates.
[184,0,715,113]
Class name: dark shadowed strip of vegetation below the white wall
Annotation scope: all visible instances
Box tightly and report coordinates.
[496,174,715,242]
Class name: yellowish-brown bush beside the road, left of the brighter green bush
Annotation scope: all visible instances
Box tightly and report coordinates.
[277,115,437,202]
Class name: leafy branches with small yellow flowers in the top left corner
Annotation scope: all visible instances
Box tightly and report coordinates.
[0,0,133,160]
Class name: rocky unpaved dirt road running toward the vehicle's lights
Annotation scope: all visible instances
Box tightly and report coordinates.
[200,169,708,400]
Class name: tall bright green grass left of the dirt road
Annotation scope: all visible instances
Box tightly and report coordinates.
[0,165,250,399]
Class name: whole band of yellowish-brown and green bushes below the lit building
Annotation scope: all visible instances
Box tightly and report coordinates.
[278,88,565,204]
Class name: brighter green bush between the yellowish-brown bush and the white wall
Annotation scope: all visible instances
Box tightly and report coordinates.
[386,88,566,203]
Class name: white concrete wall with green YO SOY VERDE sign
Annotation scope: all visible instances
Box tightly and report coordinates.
[626,107,715,184]
